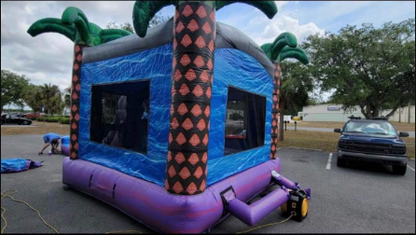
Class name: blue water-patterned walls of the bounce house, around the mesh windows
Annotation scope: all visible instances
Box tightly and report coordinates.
[79,44,273,186]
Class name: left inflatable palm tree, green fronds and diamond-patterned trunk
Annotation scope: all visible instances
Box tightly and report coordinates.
[27,7,131,159]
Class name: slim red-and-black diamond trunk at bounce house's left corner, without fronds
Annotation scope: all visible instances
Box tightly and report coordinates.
[69,44,85,160]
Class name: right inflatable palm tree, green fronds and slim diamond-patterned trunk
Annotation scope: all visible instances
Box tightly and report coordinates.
[261,33,309,153]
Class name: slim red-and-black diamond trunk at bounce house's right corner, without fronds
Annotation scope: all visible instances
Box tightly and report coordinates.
[270,64,281,159]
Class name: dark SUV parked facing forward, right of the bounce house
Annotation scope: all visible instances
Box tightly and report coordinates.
[335,119,409,175]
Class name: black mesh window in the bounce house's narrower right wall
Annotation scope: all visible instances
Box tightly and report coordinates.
[224,87,266,155]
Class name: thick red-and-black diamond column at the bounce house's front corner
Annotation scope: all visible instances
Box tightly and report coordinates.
[165,2,216,195]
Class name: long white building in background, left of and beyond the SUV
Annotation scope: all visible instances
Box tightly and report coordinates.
[298,104,365,122]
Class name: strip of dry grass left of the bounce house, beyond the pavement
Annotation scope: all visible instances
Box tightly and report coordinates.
[1,121,69,136]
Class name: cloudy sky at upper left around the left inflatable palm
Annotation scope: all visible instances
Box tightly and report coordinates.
[1,1,134,89]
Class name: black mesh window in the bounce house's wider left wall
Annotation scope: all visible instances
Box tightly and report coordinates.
[90,81,150,153]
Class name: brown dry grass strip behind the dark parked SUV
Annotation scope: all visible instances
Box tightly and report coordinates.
[278,127,415,161]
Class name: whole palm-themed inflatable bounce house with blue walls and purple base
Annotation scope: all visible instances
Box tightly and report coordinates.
[28,1,310,233]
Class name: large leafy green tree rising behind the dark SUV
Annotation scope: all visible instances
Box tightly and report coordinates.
[305,18,415,118]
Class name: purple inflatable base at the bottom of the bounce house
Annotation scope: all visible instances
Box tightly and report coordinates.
[63,157,289,233]
